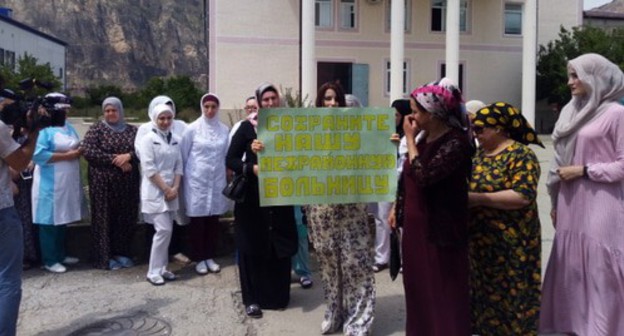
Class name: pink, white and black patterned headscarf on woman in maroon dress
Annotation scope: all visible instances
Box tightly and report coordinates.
[411,78,468,131]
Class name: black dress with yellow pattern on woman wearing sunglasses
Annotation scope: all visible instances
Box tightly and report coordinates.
[469,142,541,336]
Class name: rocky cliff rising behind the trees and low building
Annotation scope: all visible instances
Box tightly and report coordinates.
[0,0,208,94]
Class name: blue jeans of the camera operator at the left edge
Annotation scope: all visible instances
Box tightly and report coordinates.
[0,207,24,336]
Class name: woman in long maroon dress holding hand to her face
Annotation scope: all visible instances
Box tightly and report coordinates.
[388,78,473,336]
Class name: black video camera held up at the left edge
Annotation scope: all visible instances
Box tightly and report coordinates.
[0,78,72,139]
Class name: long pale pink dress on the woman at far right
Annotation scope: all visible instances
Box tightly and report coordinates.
[540,105,624,336]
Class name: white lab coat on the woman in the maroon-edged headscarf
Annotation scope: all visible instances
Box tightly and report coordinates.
[182,116,232,217]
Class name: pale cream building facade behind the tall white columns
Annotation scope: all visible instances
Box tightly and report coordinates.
[209,0,582,123]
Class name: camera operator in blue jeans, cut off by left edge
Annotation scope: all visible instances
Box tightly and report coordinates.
[0,95,39,336]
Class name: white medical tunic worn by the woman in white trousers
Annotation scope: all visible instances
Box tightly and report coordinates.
[139,131,183,214]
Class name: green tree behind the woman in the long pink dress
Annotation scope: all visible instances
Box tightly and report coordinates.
[537,26,624,103]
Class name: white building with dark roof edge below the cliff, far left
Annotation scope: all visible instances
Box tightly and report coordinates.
[0,8,67,90]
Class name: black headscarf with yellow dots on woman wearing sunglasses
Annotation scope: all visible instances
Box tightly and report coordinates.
[472,102,544,148]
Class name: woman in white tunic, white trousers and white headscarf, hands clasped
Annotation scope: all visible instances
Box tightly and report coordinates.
[139,104,183,286]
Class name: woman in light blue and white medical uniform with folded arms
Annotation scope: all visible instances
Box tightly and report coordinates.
[32,93,83,273]
